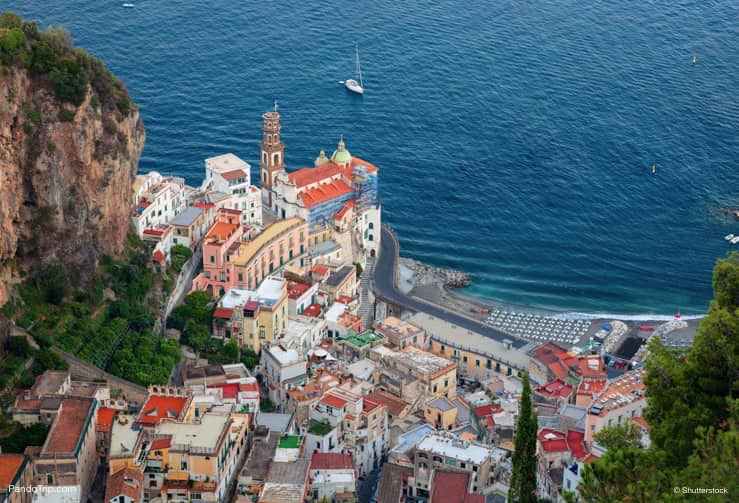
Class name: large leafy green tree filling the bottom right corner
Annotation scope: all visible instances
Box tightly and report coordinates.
[578,253,739,502]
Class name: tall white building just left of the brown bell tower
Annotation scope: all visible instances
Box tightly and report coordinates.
[201,154,262,225]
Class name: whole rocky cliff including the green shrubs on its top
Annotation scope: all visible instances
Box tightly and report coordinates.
[0,13,145,303]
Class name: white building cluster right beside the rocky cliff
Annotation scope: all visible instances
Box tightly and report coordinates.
[131,171,186,237]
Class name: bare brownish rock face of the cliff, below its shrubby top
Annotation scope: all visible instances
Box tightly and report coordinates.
[0,66,145,305]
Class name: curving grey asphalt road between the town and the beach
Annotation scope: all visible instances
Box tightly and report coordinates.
[372,225,528,349]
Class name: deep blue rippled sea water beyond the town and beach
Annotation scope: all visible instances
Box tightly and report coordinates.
[7,0,739,314]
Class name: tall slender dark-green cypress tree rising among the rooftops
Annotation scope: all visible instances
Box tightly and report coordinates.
[508,373,538,503]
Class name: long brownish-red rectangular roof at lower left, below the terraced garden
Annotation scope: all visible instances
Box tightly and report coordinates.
[42,398,95,454]
